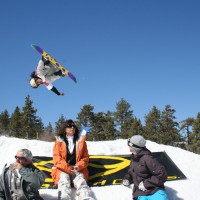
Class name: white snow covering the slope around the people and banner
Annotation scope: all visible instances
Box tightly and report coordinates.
[0,136,200,200]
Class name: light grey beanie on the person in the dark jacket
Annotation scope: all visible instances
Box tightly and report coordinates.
[128,135,146,152]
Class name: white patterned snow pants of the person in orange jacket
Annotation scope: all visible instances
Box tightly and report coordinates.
[58,172,95,200]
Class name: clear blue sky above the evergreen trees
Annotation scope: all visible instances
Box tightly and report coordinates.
[0,0,200,125]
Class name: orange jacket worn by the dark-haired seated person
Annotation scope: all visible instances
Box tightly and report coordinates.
[51,136,89,184]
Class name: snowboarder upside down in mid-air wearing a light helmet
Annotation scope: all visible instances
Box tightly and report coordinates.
[30,57,65,96]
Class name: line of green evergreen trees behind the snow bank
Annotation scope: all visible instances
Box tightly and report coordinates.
[0,95,200,154]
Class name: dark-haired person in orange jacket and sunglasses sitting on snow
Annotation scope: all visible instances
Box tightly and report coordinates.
[51,119,94,200]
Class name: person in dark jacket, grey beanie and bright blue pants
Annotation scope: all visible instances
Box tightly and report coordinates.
[122,135,168,200]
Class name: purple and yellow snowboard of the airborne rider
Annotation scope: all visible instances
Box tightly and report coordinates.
[31,44,77,83]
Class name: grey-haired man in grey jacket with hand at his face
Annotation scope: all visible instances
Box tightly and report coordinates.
[0,149,45,200]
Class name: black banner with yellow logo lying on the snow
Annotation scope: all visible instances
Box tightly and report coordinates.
[33,152,186,188]
